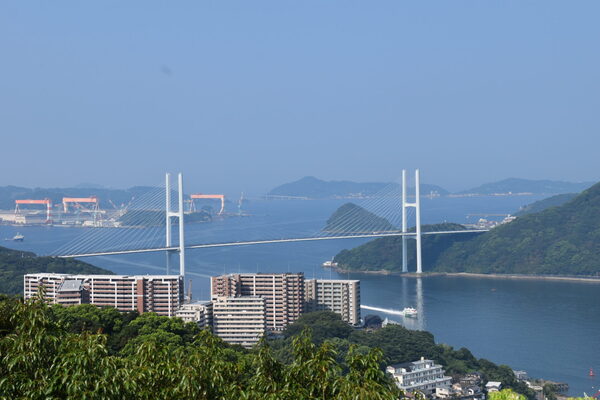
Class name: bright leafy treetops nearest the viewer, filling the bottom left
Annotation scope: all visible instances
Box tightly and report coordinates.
[0,297,401,400]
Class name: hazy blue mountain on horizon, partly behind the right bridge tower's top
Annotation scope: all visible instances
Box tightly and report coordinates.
[268,176,448,199]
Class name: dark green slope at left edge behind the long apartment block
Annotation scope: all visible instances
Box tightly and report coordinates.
[0,247,112,294]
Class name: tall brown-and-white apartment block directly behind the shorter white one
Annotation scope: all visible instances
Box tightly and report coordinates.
[211,272,305,332]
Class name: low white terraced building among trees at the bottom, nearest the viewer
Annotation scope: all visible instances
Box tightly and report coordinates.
[386,357,452,396]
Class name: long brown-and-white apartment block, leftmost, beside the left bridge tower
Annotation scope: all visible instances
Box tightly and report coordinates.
[23,273,183,317]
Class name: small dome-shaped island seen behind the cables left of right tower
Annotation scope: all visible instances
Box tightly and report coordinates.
[323,203,397,233]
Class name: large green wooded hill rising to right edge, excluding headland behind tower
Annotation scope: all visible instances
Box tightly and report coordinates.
[435,184,600,275]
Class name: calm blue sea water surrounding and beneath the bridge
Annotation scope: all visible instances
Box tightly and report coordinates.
[0,196,600,395]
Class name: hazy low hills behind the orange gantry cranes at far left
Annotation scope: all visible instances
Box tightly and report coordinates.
[0,186,153,210]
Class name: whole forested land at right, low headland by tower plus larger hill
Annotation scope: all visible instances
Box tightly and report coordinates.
[335,184,600,276]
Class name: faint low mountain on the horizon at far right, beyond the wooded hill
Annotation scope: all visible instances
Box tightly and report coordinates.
[459,178,594,194]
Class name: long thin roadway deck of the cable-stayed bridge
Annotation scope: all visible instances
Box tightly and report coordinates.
[58,229,489,258]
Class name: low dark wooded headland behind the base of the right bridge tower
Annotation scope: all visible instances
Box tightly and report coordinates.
[334,223,481,272]
